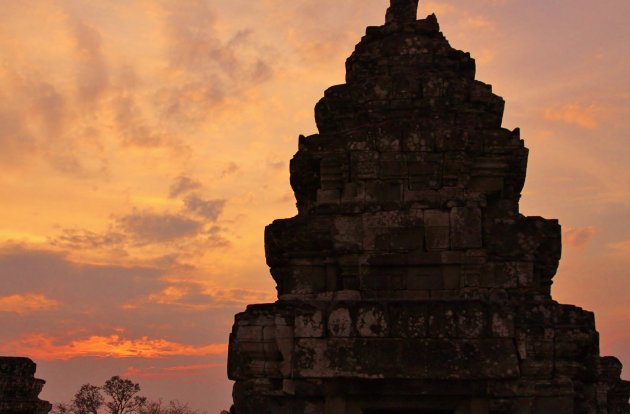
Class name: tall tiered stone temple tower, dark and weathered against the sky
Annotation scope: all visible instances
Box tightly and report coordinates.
[228,0,630,414]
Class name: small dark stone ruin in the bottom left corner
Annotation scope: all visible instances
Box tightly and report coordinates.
[0,357,52,414]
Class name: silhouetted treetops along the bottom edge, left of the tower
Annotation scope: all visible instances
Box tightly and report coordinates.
[50,375,217,414]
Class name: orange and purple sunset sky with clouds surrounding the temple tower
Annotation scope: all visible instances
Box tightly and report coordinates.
[0,0,630,414]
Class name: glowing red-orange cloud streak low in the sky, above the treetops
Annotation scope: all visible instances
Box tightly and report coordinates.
[0,334,227,361]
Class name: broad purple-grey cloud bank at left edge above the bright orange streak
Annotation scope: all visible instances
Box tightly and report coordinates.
[0,245,163,342]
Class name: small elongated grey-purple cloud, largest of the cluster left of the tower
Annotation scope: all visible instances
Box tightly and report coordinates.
[117,211,203,243]
